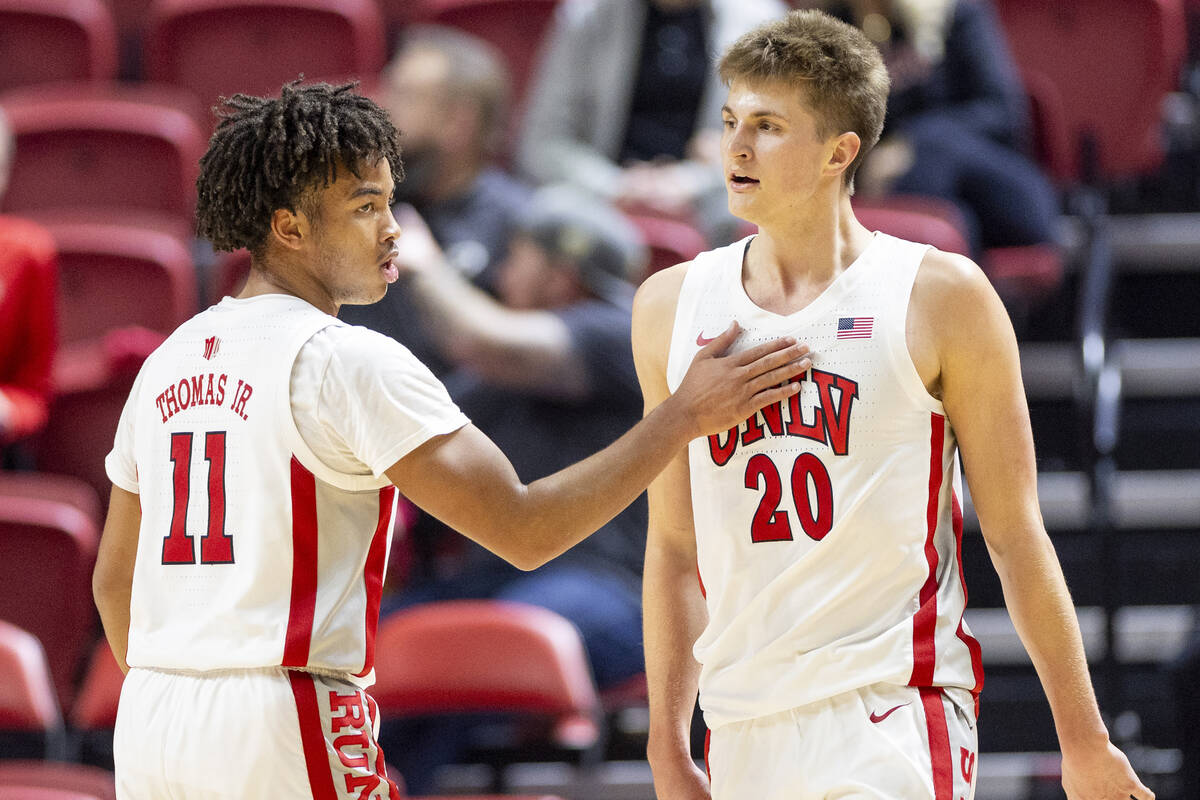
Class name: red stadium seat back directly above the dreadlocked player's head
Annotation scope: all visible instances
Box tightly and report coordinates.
[146,0,386,115]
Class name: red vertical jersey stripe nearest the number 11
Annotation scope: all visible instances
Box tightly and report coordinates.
[283,456,317,667]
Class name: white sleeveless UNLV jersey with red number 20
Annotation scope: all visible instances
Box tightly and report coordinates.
[667,234,983,728]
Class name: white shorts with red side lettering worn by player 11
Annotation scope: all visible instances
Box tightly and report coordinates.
[113,668,400,800]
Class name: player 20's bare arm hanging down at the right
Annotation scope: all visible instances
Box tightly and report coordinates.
[910,251,1154,800]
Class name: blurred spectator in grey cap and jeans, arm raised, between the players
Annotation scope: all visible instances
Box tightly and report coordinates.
[384,187,647,794]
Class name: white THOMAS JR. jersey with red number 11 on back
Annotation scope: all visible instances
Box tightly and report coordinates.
[109,296,412,686]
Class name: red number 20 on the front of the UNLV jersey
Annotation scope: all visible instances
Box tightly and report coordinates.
[745,453,833,542]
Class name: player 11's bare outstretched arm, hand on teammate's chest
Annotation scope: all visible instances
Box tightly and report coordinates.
[388,291,808,570]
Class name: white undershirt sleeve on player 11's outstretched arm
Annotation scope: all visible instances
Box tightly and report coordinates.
[292,325,469,477]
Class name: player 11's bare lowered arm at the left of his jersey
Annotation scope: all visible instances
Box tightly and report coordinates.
[91,486,142,672]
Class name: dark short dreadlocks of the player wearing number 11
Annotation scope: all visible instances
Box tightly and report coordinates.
[196,80,404,255]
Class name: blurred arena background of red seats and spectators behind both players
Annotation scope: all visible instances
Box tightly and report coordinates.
[0,0,1200,799]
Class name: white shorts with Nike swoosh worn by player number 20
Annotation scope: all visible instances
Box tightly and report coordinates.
[706,684,978,800]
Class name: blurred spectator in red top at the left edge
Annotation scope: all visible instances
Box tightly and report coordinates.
[0,112,58,468]
